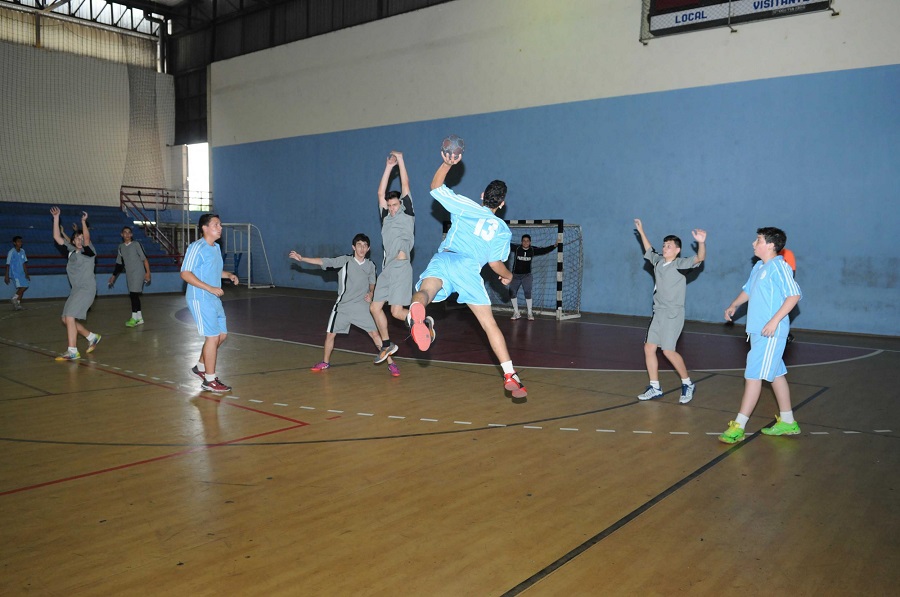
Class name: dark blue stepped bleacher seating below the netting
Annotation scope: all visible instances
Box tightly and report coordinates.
[0,201,178,276]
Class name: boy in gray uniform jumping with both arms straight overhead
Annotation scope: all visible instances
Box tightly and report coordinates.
[369,151,416,364]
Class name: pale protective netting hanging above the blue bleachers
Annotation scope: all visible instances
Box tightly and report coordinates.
[0,9,174,205]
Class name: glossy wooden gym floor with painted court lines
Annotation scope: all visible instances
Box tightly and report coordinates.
[0,288,900,596]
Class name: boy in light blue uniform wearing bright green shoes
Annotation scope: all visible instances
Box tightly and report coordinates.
[719,228,801,444]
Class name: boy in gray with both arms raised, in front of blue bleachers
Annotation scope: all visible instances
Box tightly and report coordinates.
[50,207,101,361]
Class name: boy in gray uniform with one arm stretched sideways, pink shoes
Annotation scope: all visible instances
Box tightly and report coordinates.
[288,234,400,377]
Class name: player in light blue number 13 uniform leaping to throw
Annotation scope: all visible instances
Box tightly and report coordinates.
[409,152,528,398]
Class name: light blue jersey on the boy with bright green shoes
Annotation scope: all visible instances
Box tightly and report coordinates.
[743,255,802,338]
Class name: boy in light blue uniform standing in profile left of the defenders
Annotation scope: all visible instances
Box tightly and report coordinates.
[181,214,238,393]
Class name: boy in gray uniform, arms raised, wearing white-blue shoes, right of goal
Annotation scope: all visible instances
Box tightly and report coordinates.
[634,218,706,404]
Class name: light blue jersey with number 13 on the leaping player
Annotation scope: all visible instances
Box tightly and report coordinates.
[431,185,512,268]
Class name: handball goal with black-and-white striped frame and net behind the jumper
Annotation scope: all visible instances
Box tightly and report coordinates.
[444,220,584,319]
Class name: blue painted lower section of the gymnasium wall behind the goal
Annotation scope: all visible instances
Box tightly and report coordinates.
[212,65,900,335]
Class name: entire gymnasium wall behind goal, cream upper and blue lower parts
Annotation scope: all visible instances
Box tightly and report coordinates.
[210,0,900,334]
